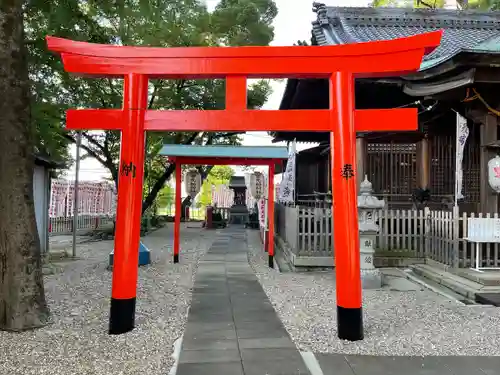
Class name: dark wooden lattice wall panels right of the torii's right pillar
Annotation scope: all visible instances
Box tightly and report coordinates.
[366,128,480,212]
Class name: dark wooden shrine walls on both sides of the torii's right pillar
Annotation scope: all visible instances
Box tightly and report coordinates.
[296,129,480,212]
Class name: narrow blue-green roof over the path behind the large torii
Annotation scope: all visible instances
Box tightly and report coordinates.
[160,144,288,159]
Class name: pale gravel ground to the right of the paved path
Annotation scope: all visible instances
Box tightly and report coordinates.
[248,231,500,356]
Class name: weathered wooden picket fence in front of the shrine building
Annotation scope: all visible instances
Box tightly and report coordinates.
[275,204,500,268]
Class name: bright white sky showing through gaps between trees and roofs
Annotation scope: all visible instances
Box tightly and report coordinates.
[65,0,370,181]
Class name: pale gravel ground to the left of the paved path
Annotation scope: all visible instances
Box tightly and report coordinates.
[0,224,216,375]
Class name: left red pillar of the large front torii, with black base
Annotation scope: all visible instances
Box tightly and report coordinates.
[109,73,148,334]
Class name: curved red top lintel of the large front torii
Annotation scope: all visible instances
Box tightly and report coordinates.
[47,31,442,79]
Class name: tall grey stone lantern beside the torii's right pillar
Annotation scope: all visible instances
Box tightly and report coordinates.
[358,175,385,289]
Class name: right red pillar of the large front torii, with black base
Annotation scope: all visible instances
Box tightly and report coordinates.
[330,72,363,341]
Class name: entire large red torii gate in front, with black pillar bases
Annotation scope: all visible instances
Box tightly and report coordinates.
[47,31,442,340]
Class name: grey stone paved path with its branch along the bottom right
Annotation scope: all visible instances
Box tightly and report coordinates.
[176,227,500,375]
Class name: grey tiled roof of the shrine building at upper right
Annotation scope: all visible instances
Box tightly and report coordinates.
[313,3,500,71]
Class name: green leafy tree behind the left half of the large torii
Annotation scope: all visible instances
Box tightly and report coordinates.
[26,0,277,211]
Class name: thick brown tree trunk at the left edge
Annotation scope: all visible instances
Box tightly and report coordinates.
[0,0,49,331]
